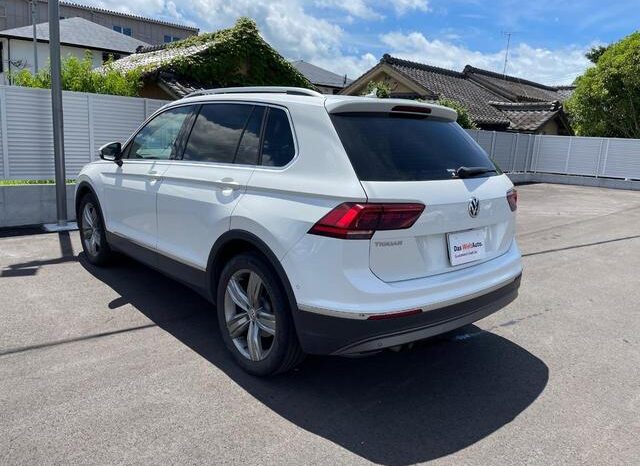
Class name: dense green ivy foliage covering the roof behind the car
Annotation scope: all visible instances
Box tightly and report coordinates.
[150,17,313,89]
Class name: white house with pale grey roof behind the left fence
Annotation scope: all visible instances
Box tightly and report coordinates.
[0,18,149,83]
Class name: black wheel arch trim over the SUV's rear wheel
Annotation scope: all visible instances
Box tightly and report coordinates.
[207,230,298,314]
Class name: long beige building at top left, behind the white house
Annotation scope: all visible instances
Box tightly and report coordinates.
[0,0,198,44]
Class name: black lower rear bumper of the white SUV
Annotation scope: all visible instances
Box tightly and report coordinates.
[296,275,521,355]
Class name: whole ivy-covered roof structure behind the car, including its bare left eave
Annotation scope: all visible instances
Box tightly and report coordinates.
[106,18,313,99]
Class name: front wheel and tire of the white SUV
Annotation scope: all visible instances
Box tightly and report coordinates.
[78,193,113,266]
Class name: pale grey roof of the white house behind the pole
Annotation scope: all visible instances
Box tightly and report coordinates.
[0,18,149,53]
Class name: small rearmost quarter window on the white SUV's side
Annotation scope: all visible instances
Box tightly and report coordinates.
[262,108,296,167]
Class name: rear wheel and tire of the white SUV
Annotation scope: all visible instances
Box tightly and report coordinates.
[216,253,304,376]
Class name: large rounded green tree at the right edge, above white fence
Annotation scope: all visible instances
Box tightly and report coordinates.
[565,32,640,138]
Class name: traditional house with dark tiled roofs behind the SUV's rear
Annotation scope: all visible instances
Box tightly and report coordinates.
[340,54,573,134]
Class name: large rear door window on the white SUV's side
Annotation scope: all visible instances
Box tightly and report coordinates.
[182,104,253,163]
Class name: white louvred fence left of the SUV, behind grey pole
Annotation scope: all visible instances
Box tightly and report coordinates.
[0,86,167,179]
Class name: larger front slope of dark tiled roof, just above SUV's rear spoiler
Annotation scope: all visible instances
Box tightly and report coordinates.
[381,55,509,126]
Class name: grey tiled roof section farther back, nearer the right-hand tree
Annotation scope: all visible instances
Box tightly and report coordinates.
[463,65,571,102]
